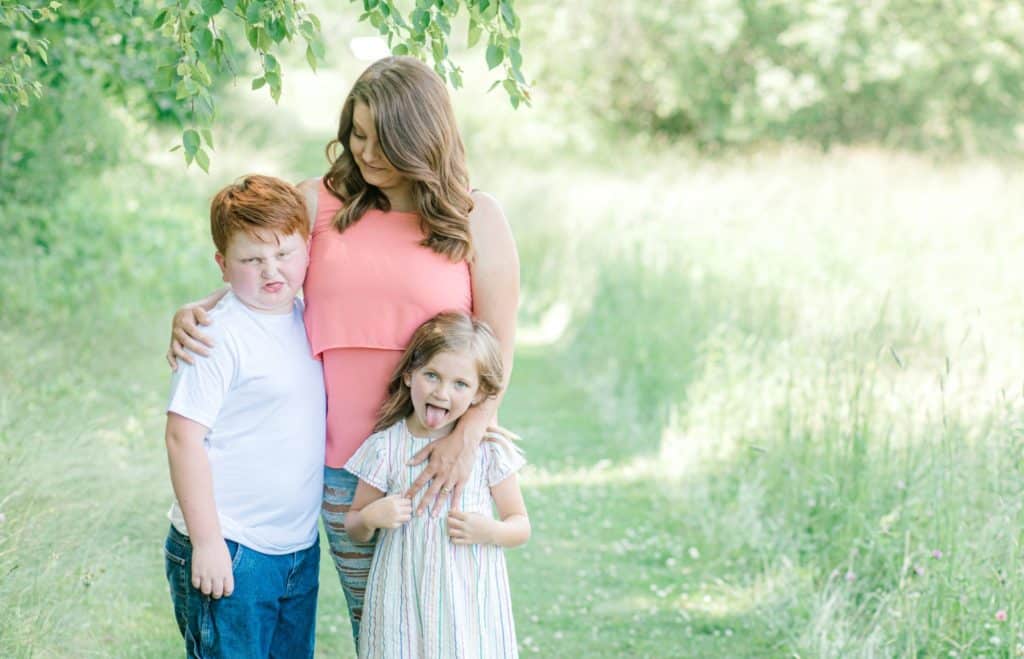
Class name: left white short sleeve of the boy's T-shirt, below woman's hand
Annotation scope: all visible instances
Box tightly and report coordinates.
[167,327,238,428]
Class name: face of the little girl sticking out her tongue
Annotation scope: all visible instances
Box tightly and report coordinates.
[403,352,480,437]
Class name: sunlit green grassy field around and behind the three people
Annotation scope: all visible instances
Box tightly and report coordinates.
[6,78,1024,657]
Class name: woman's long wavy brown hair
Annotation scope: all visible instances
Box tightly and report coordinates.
[324,57,473,261]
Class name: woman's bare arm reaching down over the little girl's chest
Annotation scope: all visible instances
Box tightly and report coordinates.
[406,192,519,514]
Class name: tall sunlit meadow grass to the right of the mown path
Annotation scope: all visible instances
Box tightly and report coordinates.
[483,143,1024,657]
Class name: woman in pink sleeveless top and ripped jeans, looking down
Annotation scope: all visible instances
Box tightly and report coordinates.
[168,57,519,647]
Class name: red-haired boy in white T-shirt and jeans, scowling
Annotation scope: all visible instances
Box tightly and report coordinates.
[165,176,326,657]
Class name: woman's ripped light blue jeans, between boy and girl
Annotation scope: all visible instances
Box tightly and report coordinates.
[321,467,377,649]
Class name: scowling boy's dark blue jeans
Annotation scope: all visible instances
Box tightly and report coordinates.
[164,526,319,659]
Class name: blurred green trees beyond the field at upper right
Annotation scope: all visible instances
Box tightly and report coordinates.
[526,0,1024,153]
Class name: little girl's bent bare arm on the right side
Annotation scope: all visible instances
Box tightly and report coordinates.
[447,474,530,546]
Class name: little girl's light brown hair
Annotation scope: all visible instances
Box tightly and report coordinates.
[374,311,505,432]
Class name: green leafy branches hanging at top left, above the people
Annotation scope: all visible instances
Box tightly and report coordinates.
[0,0,529,170]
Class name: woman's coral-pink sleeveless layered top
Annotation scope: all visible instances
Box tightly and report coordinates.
[303,181,473,466]
